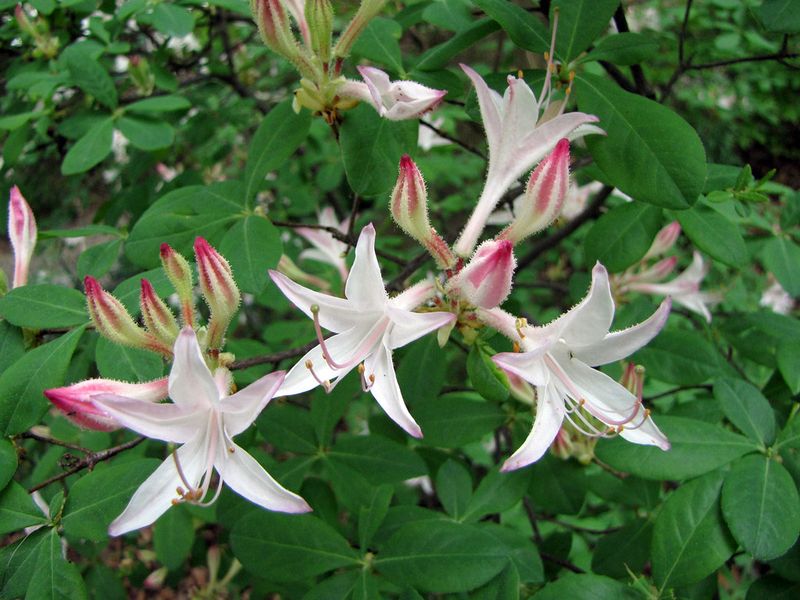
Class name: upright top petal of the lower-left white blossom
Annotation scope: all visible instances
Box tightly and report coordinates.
[169,327,219,408]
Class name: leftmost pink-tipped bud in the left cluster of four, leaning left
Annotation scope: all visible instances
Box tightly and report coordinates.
[83,275,172,356]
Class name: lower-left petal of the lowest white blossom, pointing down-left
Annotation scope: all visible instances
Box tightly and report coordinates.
[108,432,206,535]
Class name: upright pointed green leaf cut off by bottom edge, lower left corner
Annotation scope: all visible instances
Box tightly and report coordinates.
[25,529,88,600]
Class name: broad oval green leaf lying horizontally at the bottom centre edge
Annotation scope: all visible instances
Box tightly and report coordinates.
[375,521,508,593]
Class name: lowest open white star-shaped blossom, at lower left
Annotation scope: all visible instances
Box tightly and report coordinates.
[92,327,311,535]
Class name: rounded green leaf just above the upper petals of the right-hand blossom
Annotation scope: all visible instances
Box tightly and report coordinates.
[585,202,661,273]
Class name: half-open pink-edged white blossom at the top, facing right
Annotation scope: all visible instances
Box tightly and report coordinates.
[339,67,447,121]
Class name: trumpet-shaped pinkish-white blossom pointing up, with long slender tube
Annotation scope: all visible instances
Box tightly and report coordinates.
[455,63,603,256]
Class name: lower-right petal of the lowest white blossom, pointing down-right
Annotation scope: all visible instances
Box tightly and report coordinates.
[214,444,311,513]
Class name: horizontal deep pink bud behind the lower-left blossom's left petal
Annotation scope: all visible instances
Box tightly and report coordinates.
[44,377,169,431]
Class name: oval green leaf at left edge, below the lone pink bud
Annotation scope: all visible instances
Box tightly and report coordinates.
[0,284,89,329]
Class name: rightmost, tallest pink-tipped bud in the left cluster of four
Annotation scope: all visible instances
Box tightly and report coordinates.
[194,237,241,348]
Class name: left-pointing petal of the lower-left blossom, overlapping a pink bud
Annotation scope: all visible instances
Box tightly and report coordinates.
[92,394,210,444]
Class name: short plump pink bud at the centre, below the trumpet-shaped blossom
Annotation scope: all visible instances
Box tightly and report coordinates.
[447,240,517,308]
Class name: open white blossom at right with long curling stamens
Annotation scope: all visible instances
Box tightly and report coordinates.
[477,263,670,471]
